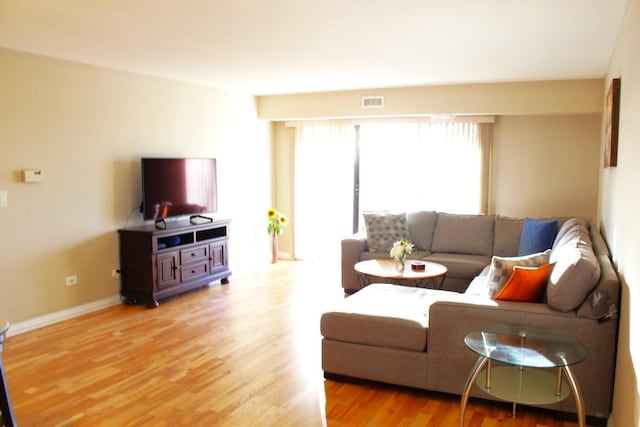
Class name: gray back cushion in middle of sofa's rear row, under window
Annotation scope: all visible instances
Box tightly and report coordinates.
[431,213,494,256]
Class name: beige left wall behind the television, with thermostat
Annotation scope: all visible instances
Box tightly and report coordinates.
[0,49,271,323]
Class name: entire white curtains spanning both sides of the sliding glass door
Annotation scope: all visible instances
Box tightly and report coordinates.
[293,122,490,259]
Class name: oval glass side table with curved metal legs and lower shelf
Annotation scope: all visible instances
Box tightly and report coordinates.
[460,326,588,427]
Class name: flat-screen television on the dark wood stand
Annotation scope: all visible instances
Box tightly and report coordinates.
[141,157,218,220]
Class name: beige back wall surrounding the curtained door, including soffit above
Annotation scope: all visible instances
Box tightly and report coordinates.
[258,79,603,252]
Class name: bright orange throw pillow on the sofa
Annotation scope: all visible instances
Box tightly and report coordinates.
[493,264,554,302]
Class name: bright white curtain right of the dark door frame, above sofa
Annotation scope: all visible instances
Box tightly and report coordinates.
[360,122,484,217]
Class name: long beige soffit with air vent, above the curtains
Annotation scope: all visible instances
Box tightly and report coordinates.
[257,79,602,120]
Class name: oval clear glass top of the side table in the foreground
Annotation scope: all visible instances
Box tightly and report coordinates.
[464,326,588,368]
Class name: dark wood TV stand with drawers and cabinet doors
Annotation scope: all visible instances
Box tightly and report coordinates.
[118,220,231,307]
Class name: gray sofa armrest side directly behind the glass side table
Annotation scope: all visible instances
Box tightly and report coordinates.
[427,299,617,417]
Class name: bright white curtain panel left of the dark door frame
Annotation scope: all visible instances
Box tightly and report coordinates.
[294,125,355,259]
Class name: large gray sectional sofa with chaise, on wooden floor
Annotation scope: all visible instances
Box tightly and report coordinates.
[320,212,620,421]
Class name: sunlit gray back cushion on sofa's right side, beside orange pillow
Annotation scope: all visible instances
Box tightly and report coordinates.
[547,220,600,311]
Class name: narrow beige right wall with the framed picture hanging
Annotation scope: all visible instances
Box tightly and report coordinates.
[599,0,640,427]
